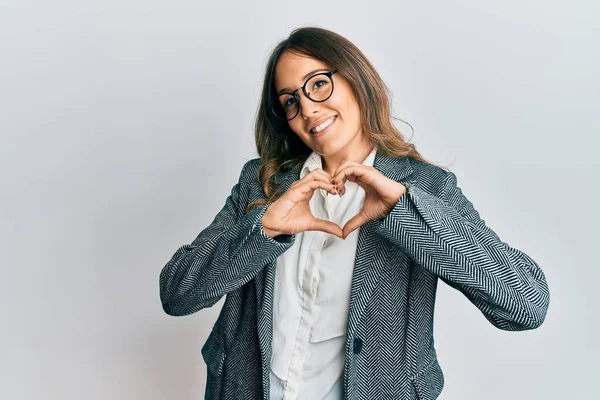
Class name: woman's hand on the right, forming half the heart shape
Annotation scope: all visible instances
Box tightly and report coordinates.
[333,161,406,239]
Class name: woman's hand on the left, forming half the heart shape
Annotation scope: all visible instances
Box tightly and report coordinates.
[262,168,342,238]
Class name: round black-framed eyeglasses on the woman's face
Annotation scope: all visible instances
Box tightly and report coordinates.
[269,69,338,121]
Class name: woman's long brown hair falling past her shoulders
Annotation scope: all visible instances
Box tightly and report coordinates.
[246,27,442,212]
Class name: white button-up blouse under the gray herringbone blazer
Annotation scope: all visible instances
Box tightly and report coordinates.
[271,148,376,400]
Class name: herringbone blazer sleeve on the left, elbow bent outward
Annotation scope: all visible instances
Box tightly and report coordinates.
[159,162,295,316]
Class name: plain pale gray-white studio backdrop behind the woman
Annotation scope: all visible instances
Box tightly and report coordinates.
[0,0,600,400]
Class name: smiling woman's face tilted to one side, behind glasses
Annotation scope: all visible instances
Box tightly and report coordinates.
[275,51,365,159]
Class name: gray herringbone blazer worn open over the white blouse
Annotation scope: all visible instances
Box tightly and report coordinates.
[159,152,550,400]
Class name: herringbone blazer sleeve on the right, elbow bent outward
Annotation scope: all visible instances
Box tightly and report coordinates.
[376,171,550,331]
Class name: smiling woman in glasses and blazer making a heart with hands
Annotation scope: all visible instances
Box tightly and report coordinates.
[160,28,549,400]
